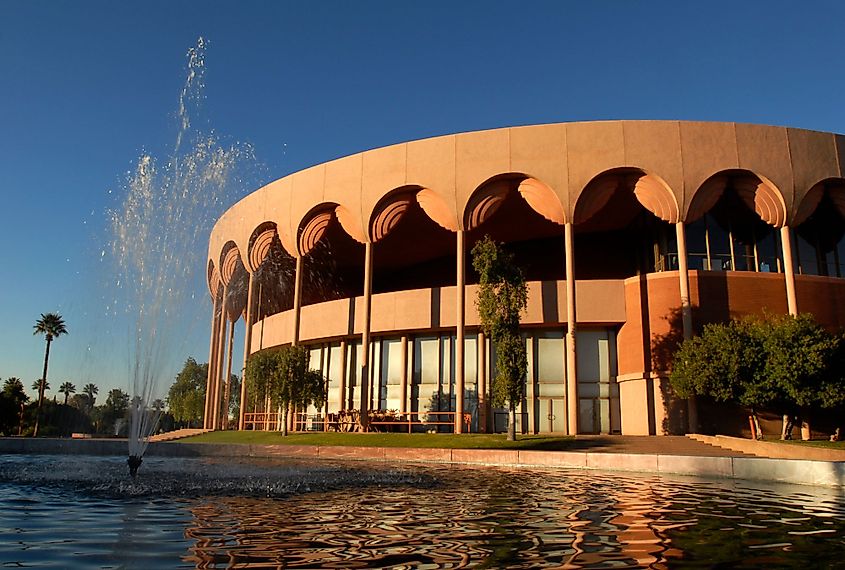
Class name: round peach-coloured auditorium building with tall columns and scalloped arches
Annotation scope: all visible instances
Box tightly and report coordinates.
[205,121,845,435]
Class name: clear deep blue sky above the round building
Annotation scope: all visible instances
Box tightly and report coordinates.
[0,0,845,397]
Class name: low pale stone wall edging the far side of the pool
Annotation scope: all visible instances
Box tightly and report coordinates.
[0,438,845,487]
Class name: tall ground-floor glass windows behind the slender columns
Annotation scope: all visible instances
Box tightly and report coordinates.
[296,328,620,433]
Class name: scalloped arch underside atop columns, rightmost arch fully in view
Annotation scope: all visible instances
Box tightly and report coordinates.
[684,170,786,228]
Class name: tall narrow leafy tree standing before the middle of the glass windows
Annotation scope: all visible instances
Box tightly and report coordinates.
[472,236,528,441]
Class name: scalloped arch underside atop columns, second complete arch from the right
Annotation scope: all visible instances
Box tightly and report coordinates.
[573,167,680,224]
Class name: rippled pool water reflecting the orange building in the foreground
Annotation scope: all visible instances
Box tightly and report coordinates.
[0,455,845,568]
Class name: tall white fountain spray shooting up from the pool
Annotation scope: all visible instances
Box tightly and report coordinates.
[103,37,253,476]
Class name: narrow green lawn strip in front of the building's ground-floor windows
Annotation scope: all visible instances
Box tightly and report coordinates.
[179,431,578,451]
